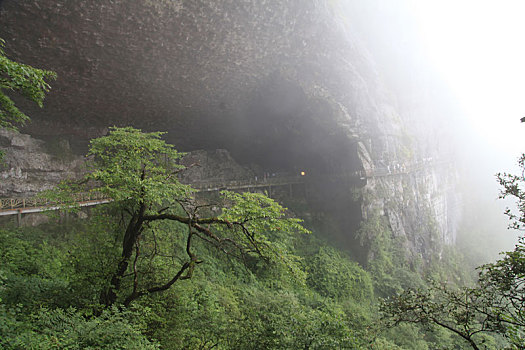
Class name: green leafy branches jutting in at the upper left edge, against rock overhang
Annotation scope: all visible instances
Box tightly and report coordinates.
[0,39,56,129]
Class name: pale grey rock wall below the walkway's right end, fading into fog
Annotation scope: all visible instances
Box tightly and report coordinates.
[362,162,462,259]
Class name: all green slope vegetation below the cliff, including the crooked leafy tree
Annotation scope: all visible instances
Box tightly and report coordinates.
[0,128,503,349]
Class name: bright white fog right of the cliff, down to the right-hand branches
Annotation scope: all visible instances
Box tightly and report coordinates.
[340,0,525,254]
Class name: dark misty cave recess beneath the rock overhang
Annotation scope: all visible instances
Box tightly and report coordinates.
[174,76,364,254]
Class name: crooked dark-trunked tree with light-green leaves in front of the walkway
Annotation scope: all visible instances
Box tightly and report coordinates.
[49,127,308,306]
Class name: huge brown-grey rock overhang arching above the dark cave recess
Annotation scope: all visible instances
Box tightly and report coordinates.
[0,0,389,149]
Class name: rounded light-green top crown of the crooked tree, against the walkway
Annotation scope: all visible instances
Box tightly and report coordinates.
[87,127,191,208]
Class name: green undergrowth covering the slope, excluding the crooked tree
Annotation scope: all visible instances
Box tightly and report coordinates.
[0,212,474,349]
